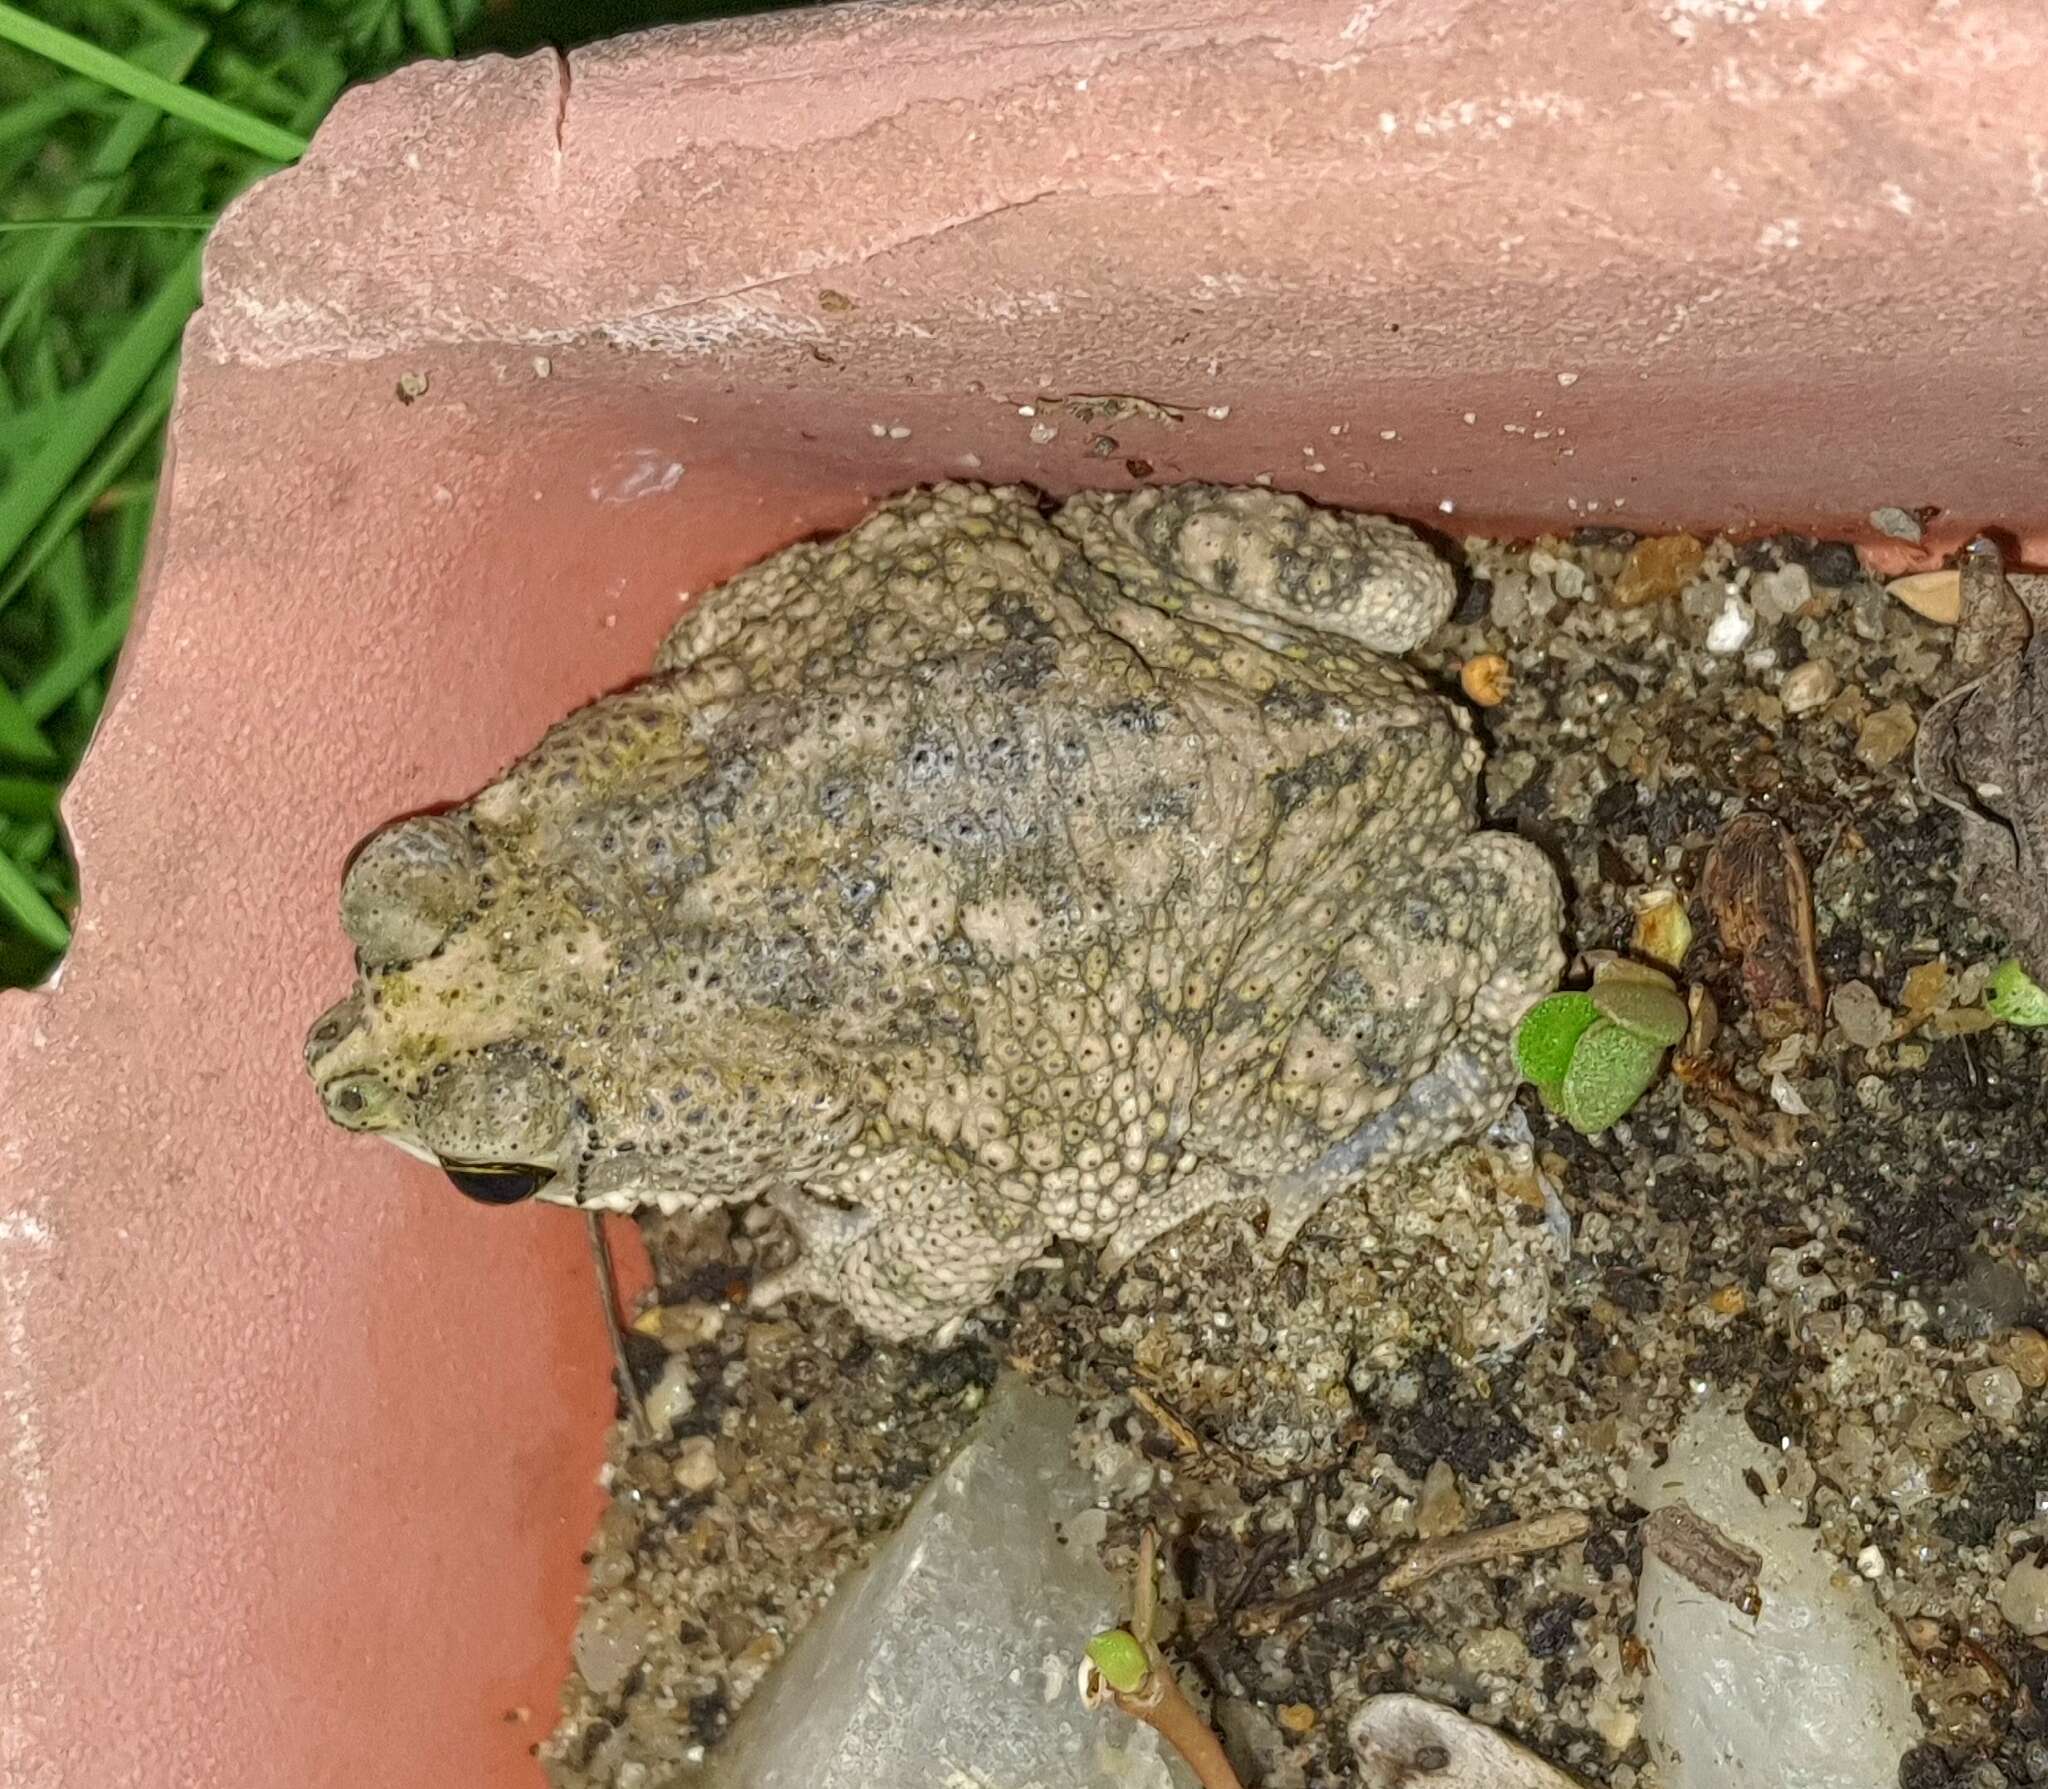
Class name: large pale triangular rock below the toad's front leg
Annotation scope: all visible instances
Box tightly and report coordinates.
[698,1378,1194,1789]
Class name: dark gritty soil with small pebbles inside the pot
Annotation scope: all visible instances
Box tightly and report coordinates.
[541,530,2048,1789]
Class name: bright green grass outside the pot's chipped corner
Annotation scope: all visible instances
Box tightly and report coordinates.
[0,0,481,985]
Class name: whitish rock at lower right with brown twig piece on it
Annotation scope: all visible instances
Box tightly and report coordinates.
[1630,1404,1923,1789]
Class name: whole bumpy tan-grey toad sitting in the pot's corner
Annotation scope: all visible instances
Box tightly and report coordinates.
[307,485,1561,1337]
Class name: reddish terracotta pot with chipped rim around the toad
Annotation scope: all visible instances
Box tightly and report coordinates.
[0,0,2048,1789]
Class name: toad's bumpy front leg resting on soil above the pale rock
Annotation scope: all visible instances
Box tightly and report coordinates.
[754,1146,1053,1341]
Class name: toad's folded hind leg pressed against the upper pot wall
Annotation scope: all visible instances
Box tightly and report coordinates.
[1055,485,1458,653]
